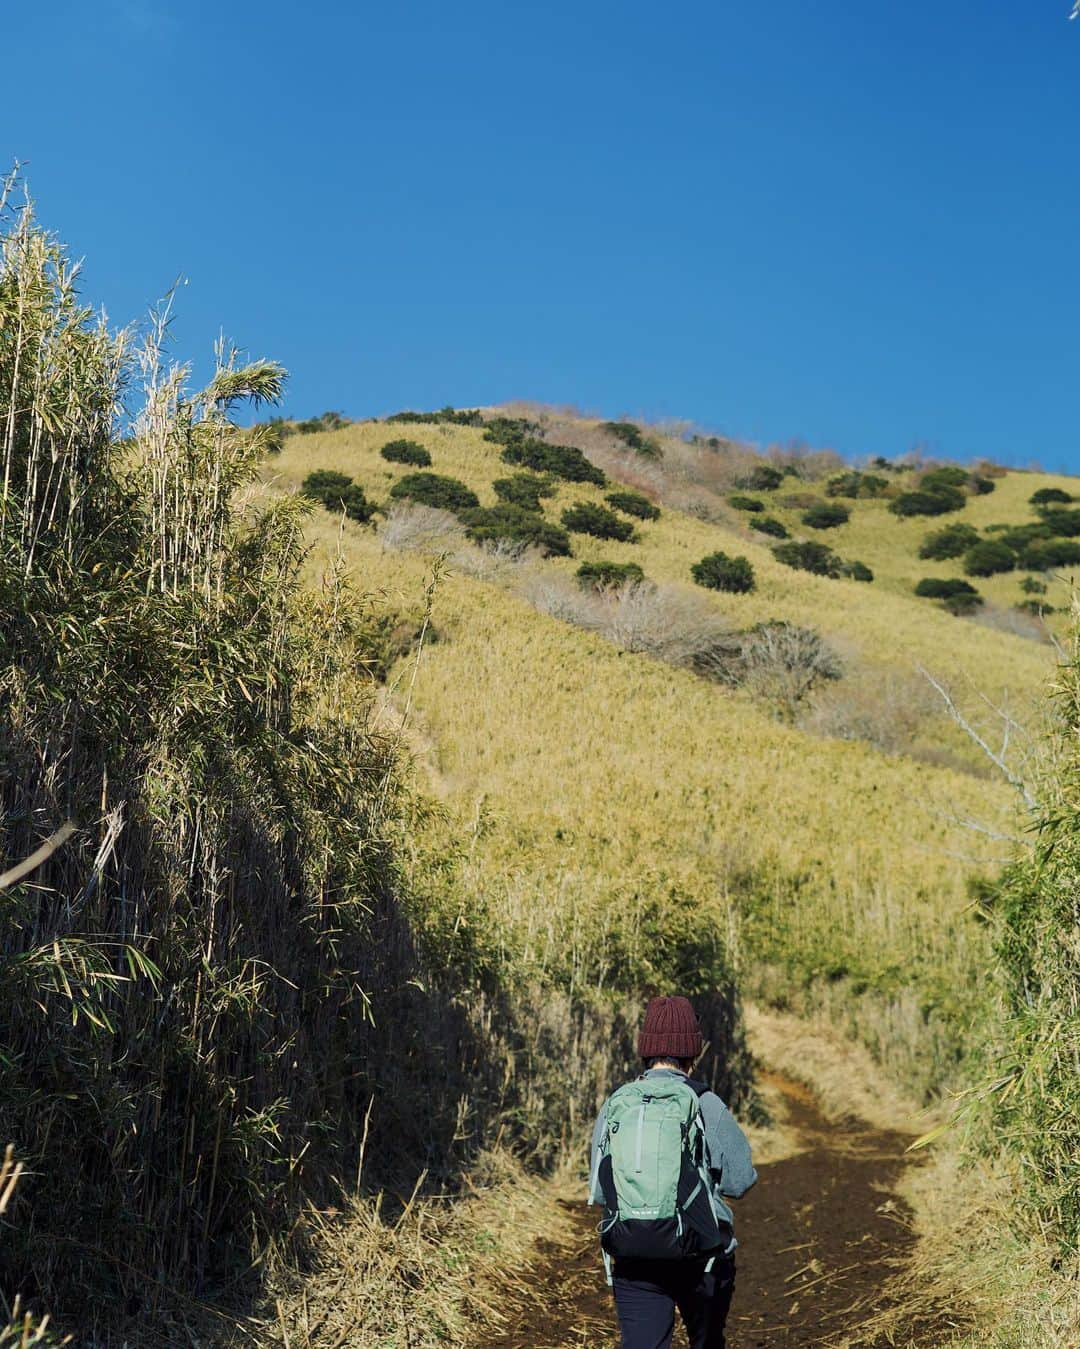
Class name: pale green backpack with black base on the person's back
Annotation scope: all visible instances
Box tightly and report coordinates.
[589,1077,731,1260]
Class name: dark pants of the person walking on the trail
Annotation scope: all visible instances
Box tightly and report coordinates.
[612,1255,735,1349]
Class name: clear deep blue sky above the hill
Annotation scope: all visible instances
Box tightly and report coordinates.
[8,0,1080,472]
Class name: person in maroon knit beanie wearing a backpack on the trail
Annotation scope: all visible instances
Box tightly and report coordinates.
[589,997,758,1349]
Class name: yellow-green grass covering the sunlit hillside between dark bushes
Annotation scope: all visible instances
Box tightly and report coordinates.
[267,420,1072,1091]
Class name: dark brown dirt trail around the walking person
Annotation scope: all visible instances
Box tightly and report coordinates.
[481,1075,956,1349]
